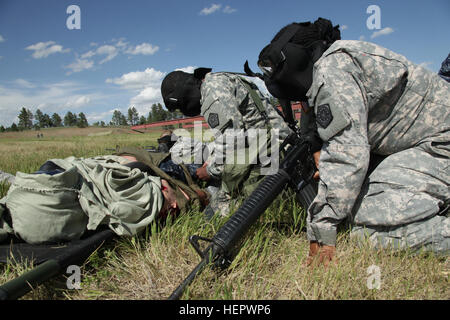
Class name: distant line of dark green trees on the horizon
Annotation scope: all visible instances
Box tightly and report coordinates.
[0,103,183,132]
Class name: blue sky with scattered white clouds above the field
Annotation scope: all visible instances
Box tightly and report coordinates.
[0,0,450,126]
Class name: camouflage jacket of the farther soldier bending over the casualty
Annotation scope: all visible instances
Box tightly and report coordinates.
[200,72,290,178]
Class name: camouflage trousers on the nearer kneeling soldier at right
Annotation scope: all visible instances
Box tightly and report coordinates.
[351,143,450,255]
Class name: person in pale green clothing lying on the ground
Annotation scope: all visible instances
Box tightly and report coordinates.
[0,148,209,244]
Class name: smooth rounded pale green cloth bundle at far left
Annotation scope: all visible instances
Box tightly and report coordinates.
[2,167,88,244]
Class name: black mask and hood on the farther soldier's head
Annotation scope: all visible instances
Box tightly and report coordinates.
[161,68,211,117]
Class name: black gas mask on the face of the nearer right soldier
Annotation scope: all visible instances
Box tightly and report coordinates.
[258,25,317,101]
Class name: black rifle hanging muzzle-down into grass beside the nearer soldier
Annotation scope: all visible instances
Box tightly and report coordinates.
[169,103,317,300]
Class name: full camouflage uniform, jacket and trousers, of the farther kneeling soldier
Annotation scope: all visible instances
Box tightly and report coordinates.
[200,72,290,215]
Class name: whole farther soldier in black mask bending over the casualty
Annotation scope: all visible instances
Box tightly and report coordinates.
[161,68,290,217]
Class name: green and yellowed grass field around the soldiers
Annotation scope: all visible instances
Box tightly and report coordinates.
[0,128,450,300]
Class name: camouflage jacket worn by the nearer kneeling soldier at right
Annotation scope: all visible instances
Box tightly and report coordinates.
[307,41,450,245]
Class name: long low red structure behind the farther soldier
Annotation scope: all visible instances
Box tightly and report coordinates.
[131,102,302,130]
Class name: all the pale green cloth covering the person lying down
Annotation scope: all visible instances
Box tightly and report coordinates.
[0,156,164,244]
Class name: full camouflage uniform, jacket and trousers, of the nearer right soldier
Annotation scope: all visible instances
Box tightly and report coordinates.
[308,41,450,254]
